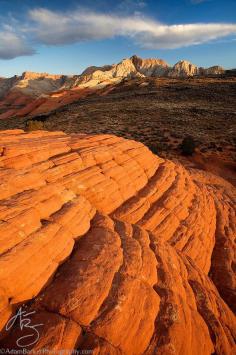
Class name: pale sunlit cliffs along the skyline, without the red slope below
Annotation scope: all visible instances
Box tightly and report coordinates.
[0,55,224,96]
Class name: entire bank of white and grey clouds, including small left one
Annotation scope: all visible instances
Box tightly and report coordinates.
[0,8,236,59]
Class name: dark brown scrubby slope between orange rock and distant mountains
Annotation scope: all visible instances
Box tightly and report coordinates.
[0,78,236,165]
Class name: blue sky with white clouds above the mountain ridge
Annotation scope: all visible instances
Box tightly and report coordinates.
[0,0,236,77]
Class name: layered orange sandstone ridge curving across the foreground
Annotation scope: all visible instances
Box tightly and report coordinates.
[0,130,236,355]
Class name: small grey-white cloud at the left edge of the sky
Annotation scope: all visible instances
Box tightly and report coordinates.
[0,31,35,59]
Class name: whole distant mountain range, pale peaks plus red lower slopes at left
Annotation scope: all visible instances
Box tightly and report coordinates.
[0,55,230,119]
